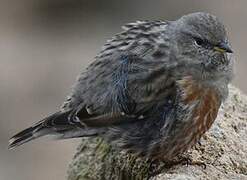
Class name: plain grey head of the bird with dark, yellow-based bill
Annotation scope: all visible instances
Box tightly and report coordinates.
[168,12,233,83]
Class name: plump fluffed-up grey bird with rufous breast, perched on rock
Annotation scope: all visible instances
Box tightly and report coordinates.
[9,12,234,160]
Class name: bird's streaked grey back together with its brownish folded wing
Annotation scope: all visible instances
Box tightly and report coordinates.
[59,21,175,126]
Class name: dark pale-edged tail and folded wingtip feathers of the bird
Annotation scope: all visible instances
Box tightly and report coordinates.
[8,105,130,149]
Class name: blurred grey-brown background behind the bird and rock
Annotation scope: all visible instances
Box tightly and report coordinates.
[0,0,247,180]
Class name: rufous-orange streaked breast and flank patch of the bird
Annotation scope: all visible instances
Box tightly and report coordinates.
[167,77,221,153]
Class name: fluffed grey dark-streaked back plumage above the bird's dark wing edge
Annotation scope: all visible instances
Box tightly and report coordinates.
[62,21,172,113]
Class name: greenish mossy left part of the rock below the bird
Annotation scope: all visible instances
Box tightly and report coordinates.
[68,138,160,180]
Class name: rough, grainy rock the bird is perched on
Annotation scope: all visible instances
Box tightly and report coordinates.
[68,86,247,180]
